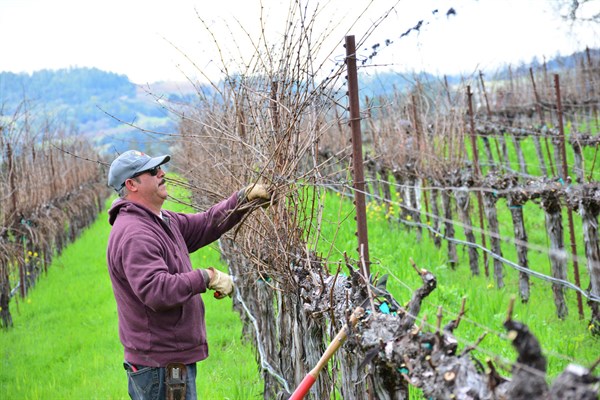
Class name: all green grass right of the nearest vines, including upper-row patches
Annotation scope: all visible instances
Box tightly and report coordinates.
[317,119,600,399]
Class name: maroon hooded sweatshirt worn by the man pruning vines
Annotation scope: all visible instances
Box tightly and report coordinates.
[107,194,243,367]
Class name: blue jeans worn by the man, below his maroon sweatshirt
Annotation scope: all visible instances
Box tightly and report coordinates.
[123,363,197,400]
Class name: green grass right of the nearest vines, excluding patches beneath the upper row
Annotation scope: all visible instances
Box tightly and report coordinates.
[319,188,600,380]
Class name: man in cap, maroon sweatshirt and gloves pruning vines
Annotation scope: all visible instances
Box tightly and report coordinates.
[107,150,271,400]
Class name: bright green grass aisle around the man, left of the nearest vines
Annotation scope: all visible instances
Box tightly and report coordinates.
[0,188,263,400]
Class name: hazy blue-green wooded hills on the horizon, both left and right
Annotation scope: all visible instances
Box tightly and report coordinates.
[0,49,600,154]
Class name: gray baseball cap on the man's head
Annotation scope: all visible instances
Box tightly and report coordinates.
[108,150,171,192]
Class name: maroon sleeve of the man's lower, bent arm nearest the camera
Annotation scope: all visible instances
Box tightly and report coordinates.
[122,234,208,311]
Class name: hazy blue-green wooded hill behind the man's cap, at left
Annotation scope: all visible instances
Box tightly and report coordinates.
[0,68,193,153]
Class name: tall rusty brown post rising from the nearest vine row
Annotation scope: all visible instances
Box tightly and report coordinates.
[346,35,371,276]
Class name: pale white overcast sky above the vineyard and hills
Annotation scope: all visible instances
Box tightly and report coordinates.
[0,0,600,84]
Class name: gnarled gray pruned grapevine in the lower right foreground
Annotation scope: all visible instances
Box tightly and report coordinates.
[304,260,600,400]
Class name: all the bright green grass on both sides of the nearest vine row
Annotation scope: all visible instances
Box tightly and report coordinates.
[0,121,600,400]
